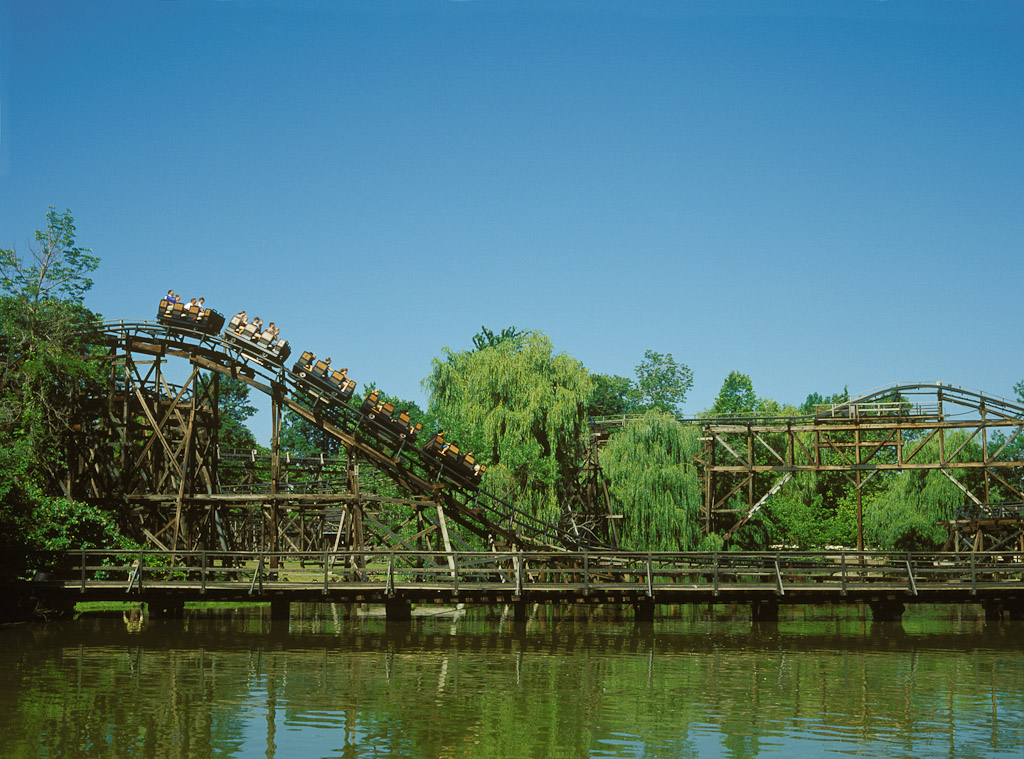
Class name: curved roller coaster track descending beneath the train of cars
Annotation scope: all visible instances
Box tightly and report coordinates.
[95,321,601,550]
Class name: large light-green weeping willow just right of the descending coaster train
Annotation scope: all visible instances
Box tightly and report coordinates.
[424,332,593,520]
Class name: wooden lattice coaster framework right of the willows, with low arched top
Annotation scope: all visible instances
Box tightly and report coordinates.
[698,383,1024,549]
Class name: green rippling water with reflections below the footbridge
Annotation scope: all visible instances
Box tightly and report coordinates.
[0,605,1024,759]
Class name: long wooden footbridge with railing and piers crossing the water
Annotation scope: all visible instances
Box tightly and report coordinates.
[34,550,1024,621]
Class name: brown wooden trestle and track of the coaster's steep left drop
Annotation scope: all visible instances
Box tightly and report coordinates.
[60,322,582,552]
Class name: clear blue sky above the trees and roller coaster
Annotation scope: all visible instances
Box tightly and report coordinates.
[0,0,1024,437]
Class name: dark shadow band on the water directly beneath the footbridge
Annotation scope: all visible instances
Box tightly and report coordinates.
[5,604,1024,653]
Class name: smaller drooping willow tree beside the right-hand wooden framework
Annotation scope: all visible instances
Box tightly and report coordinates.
[601,411,721,551]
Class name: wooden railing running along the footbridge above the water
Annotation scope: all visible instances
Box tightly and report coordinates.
[55,550,1024,597]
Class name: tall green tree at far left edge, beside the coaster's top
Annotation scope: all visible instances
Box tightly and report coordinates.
[0,208,133,578]
